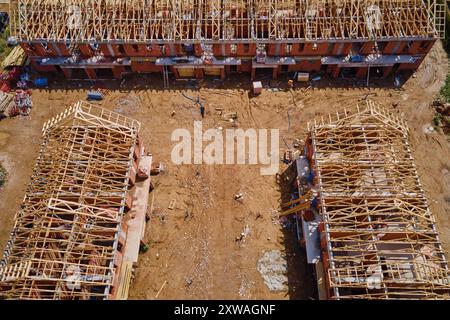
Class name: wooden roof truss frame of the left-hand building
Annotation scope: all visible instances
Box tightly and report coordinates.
[0,102,140,299]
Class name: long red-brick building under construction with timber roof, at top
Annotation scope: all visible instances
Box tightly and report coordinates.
[7,0,445,85]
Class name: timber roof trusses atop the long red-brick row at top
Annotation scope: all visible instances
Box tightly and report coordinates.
[11,0,445,44]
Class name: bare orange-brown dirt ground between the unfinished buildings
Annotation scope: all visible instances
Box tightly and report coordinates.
[0,43,450,299]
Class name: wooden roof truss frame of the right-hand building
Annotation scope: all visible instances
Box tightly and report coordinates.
[309,101,450,299]
